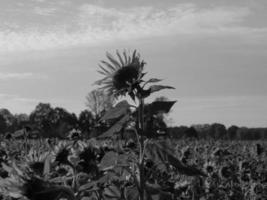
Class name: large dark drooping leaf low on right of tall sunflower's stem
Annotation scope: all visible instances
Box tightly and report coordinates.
[146,140,206,176]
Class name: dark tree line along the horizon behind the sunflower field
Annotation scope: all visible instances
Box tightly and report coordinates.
[0,90,267,140]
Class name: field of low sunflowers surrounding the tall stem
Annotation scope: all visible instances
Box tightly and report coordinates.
[0,139,267,200]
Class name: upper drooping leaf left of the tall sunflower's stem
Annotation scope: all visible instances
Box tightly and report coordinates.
[101,100,130,120]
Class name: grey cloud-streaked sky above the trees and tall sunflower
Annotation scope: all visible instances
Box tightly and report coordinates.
[0,0,267,127]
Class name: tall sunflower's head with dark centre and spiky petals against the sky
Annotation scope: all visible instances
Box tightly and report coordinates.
[96,50,145,99]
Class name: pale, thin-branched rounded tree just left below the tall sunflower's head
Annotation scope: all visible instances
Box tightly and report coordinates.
[86,89,115,119]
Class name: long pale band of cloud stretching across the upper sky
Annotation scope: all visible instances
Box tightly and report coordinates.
[0,4,267,52]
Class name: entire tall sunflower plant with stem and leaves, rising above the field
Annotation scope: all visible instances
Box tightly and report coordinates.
[96,51,205,200]
